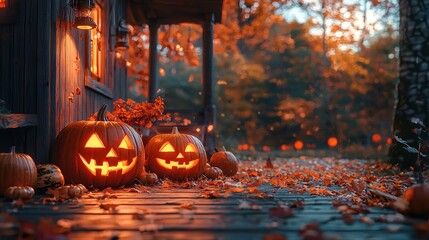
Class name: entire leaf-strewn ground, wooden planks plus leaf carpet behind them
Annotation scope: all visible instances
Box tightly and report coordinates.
[0,157,429,239]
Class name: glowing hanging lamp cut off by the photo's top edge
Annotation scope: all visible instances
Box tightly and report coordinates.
[73,0,97,30]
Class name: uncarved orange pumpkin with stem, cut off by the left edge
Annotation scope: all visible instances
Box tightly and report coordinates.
[0,146,37,195]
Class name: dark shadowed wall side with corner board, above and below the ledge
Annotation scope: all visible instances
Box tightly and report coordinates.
[0,0,51,159]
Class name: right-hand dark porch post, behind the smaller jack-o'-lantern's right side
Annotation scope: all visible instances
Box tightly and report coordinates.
[203,13,216,155]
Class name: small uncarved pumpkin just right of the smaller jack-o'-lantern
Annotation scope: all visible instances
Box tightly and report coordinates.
[210,147,238,177]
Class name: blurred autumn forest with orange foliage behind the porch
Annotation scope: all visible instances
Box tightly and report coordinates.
[121,0,399,157]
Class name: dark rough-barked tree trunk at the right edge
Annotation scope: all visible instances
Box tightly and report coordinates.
[389,0,429,168]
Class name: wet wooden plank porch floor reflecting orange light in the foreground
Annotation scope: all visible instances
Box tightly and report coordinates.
[0,158,427,240]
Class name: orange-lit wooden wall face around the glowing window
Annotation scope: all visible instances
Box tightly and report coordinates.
[53,1,126,161]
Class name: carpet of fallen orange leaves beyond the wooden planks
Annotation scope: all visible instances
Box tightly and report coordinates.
[162,158,415,207]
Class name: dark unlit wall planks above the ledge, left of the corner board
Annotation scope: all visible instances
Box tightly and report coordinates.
[0,0,38,113]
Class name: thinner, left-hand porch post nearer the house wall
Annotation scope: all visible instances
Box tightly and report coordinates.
[148,19,159,102]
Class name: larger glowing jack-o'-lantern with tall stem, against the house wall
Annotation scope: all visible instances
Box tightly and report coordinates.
[52,105,145,188]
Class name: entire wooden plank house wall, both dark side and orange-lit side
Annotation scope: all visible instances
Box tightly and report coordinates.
[0,0,126,163]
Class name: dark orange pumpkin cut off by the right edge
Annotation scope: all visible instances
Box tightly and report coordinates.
[403,184,429,216]
